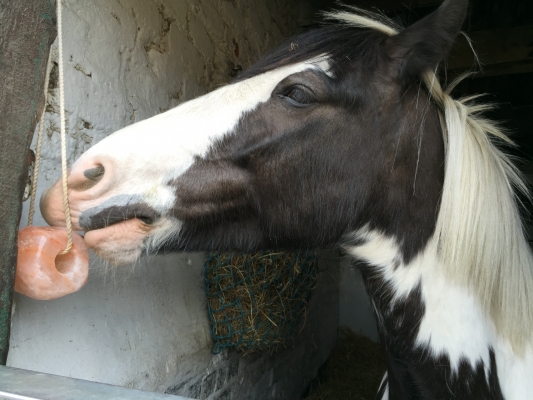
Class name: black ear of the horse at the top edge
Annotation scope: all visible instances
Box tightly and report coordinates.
[386,0,468,77]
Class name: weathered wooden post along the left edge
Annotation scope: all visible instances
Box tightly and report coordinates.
[0,0,56,365]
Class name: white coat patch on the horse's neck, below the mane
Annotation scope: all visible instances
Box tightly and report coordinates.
[345,229,533,400]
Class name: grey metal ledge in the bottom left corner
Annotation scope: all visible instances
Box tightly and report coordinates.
[0,366,192,400]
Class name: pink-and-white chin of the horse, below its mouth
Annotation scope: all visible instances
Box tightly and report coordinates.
[85,218,153,266]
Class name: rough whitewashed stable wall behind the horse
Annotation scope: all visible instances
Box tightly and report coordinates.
[8,0,338,400]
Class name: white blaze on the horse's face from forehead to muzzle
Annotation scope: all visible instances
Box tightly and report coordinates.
[72,61,327,213]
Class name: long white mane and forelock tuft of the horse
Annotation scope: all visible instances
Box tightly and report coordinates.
[324,7,533,352]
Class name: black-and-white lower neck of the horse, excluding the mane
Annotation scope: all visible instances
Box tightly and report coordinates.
[346,230,508,398]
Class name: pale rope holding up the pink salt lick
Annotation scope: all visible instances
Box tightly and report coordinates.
[28,0,72,254]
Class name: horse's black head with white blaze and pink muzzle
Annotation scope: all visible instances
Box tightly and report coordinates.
[41,0,467,264]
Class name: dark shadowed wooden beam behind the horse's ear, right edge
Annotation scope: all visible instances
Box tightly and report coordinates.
[448,24,533,76]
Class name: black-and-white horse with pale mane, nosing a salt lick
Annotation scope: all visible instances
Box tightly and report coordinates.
[41,0,533,400]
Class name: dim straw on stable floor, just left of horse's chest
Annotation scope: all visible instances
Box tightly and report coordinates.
[305,327,385,400]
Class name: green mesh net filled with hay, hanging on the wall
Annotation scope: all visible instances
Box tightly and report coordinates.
[204,252,318,354]
